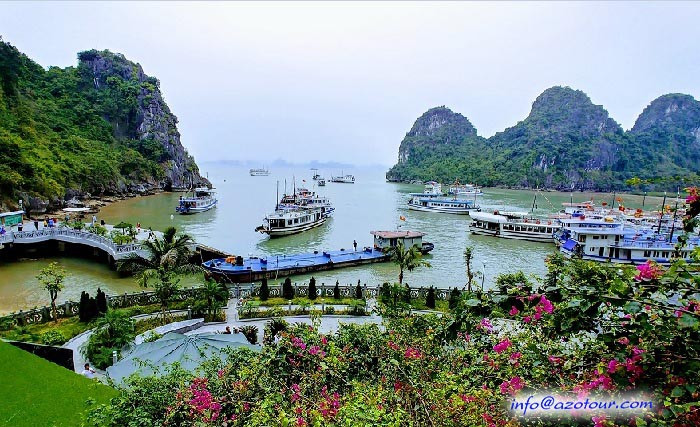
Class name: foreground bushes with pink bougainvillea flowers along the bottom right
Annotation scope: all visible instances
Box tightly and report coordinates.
[90,256,700,426]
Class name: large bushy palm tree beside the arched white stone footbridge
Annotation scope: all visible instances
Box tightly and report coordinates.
[117,227,202,320]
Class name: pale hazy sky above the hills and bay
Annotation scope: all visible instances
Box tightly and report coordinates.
[0,2,700,165]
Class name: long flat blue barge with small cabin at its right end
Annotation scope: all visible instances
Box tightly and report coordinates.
[202,231,434,283]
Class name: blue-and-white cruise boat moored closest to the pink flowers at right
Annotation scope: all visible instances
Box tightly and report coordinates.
[557,224,700,264]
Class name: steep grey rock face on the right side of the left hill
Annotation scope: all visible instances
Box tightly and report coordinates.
[78,50,209,190]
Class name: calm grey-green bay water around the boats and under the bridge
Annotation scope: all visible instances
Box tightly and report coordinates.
[0,164,661,313]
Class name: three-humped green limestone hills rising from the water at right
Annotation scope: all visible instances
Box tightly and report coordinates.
[387,87,700,190]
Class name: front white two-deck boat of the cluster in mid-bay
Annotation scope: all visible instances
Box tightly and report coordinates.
[255,206,328,237]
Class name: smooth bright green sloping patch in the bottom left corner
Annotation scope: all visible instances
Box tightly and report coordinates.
[0,342,117,427]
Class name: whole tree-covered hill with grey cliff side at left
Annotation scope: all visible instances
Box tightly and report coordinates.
[0,39,204,209]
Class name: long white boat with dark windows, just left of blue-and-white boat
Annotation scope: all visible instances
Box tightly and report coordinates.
[469,211,561,243]
